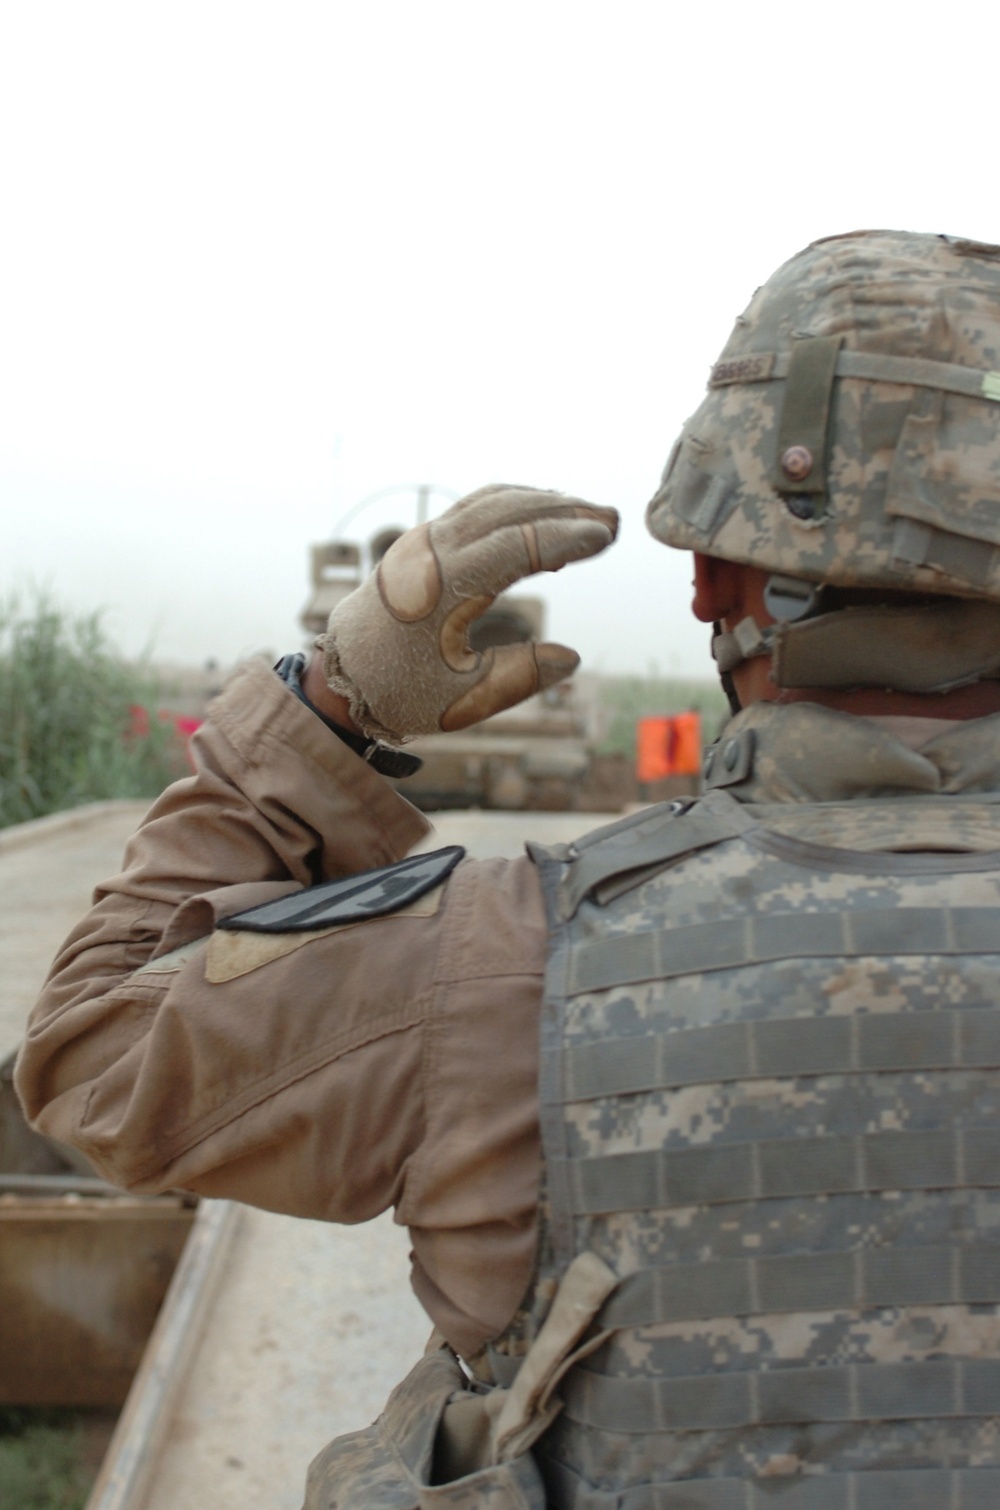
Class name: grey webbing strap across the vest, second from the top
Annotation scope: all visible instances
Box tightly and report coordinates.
[563,1007,1000,1101]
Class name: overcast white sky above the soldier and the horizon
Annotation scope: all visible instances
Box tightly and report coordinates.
[0,0,1000,675]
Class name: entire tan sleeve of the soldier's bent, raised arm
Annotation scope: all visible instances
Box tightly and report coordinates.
[17,655,547,1356]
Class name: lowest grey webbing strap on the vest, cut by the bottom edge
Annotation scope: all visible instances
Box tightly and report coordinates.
[542,1457,1000,1510]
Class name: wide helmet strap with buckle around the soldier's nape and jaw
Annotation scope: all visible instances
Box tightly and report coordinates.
[711,577,1000,705]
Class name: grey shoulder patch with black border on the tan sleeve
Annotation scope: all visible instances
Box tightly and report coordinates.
[218,844,465,933]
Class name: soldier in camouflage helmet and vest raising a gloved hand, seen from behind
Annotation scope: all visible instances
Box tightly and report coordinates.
[20,231,1000,1510]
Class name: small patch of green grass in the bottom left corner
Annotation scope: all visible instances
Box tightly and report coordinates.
[0,1407,94,1510]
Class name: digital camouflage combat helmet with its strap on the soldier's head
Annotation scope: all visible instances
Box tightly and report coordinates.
[647,231,1000,690]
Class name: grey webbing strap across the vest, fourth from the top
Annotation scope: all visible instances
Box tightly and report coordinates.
[598,1246,1000,1328]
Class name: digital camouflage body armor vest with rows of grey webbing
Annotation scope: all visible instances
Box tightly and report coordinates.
[513,791,1000,1510]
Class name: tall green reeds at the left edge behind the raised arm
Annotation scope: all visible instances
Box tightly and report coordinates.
[0,593,178,827]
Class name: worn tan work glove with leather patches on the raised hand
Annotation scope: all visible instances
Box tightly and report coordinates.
[316,486,618,744]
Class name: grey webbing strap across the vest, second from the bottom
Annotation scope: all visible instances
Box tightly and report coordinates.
[562,1359,1000,1435]
